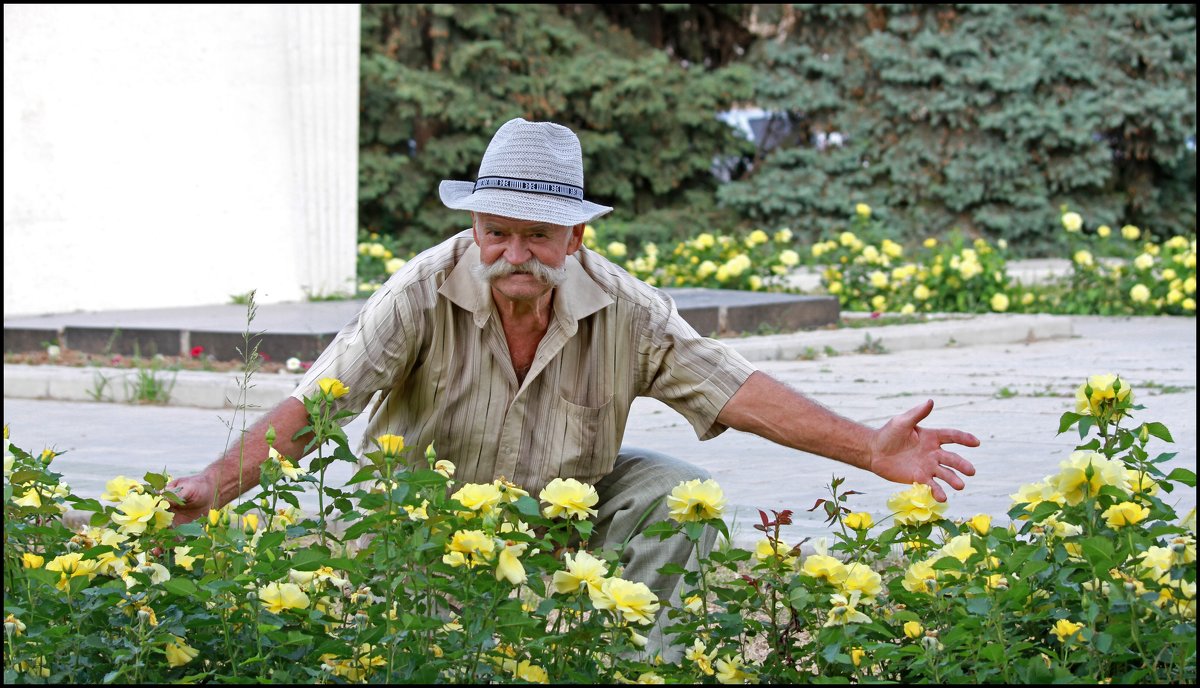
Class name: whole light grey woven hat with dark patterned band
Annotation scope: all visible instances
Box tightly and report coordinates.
[438,118,612,226]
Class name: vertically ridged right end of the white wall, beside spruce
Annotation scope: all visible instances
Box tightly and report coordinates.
[287,5,360,297]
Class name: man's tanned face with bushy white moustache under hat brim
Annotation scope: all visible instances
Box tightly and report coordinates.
[474,213,583,301]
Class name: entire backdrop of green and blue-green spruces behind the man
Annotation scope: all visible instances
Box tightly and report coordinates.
[360,4,1196,256]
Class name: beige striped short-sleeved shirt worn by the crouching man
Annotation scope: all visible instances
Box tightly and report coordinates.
[292,231,755,496]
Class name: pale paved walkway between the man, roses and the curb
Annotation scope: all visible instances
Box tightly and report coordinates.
[4,316,1196,546]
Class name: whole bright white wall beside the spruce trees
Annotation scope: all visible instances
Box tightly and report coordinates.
[4,5,359,316]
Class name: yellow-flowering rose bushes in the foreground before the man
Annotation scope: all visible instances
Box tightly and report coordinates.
[4,375,1196,683]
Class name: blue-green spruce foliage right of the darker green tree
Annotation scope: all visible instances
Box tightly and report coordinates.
[719,5,1195,255]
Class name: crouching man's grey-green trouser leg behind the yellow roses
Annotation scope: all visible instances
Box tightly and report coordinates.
[588,447,716,663]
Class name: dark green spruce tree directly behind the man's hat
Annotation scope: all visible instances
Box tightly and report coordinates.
[359,4,751,250]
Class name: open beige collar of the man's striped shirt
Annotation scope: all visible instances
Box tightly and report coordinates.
[438,243,613,336]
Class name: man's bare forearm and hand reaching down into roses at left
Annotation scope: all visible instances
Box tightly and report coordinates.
[167,396,312,525]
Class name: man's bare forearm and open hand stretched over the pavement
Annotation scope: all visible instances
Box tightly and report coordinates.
[716,371,979,502]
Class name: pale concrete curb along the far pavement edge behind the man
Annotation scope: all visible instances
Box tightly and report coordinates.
[4,313,1073,408]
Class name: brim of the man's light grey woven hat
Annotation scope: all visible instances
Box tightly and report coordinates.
[438,179,612,227]
